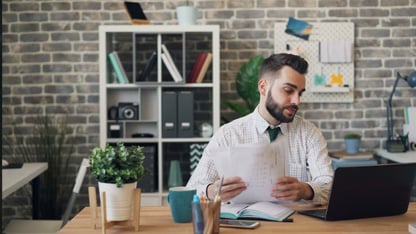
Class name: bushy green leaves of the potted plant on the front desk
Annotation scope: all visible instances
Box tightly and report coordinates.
[90,142,145,187]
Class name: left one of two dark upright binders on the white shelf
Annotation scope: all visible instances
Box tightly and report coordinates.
[162,91,178,138]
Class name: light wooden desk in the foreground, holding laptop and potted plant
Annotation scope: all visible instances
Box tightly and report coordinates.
[59,203,416,234]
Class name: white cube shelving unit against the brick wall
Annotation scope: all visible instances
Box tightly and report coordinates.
[99,25,220,205]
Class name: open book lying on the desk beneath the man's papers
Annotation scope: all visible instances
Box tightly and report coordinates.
[220,202,295,221]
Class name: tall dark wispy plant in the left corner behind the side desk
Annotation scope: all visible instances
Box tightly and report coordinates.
[2,115,74,219]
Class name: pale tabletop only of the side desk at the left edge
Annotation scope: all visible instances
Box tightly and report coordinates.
[1,163,48,200]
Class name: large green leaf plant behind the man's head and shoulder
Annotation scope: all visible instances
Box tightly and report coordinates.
[222,55,264,122]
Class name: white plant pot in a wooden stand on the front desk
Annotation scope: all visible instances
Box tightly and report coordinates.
[98,182,137,221]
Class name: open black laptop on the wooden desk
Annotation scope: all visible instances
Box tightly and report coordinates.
[298,163,416,221]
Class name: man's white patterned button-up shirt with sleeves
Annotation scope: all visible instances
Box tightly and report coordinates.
[187,108,334,204]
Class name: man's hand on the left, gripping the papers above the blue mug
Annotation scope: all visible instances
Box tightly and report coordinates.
[207,176,247,202]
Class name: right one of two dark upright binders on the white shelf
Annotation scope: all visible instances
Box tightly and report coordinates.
[178,91,194,137]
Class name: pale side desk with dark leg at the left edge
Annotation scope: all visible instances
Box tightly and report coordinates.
[1,163,48,219]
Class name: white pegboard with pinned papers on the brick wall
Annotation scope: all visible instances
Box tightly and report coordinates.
[274,22,354,103]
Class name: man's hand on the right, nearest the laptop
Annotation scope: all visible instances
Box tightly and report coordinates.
[272,176,313,201]
